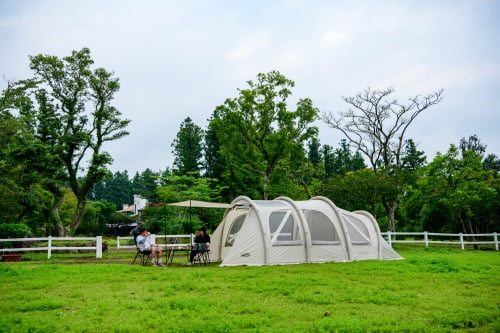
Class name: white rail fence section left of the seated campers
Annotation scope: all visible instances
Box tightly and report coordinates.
[0,236,102,259]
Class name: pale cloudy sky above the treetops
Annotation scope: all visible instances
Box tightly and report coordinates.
[0,0,500,177]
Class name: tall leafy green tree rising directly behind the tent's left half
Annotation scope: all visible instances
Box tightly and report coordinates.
[212,71,318,199]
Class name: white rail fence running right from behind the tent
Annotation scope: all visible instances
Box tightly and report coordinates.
[382,231,499,251]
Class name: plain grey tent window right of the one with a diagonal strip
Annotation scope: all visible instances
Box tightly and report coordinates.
[303,209,340,245]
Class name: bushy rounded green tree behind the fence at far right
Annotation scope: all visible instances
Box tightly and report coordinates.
[419,145,500,233]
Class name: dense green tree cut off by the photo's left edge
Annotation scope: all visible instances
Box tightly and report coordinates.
[0,80,54,232]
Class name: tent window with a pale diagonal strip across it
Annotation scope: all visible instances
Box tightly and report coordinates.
[269,211,302,245]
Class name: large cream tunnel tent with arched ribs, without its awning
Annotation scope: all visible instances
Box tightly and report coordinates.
[210,196,402,266]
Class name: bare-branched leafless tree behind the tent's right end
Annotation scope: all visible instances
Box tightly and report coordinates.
[323,88,443,231]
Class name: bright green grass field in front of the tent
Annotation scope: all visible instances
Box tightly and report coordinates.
[0,247,500,332]
